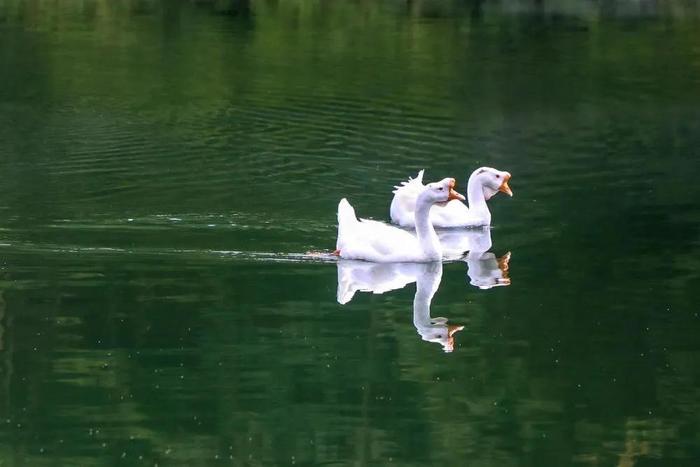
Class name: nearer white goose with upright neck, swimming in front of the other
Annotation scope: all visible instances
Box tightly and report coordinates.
[335,178,464,263]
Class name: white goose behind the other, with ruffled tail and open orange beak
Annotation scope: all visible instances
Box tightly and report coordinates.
[390,167,513,227]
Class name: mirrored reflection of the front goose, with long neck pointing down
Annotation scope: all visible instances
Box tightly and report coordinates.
[338,260,464,352]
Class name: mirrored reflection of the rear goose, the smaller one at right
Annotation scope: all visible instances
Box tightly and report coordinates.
[437,227,510,290]
